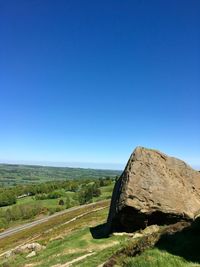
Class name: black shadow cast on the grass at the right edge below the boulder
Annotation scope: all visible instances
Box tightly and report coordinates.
[156,219,200,263]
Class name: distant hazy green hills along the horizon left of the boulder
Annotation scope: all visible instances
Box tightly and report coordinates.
[0,164,121,186]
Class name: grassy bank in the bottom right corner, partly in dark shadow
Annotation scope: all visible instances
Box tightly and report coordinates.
[104,219,200,267]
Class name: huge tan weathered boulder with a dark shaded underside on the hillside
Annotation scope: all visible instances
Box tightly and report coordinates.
[108,147,200,232]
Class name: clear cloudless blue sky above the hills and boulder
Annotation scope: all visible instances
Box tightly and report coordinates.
[0,0,200,168]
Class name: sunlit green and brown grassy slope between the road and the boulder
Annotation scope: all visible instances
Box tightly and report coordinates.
[0,201,130,267]
